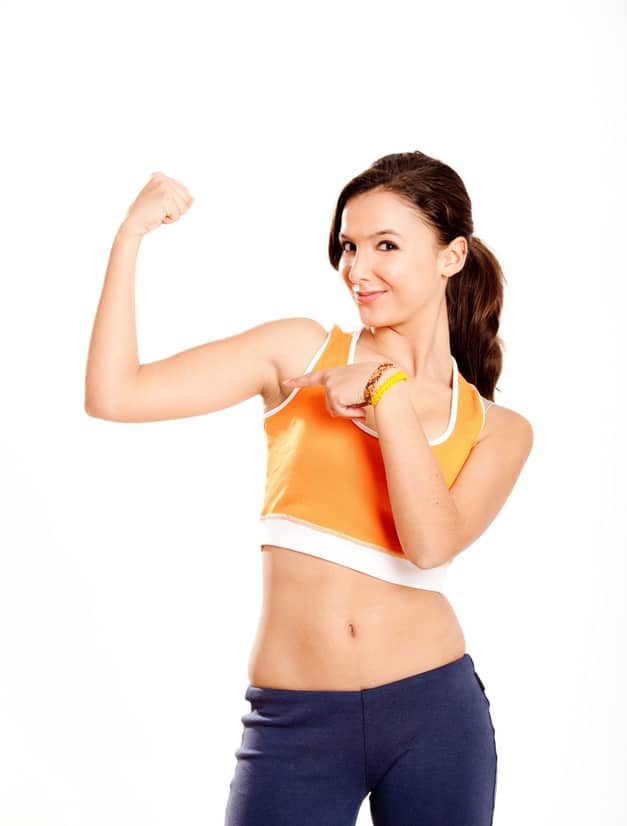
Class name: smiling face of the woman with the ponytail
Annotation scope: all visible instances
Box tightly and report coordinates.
[338,190,461,318]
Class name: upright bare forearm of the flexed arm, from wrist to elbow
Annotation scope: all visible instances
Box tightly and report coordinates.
[85,223,142,416]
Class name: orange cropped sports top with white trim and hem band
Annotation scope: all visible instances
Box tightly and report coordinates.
[259,324,493,591]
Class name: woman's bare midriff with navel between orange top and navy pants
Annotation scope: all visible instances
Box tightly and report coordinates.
[248,545,466,691]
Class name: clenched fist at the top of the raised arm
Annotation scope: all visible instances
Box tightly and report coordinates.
[122,172,194,236]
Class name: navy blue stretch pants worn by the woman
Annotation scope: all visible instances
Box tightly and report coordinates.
[224,653,497,826]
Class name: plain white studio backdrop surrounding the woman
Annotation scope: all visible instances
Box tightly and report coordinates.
[0,0,627,826]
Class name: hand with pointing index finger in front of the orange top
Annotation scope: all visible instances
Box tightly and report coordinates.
[281,361,392,419]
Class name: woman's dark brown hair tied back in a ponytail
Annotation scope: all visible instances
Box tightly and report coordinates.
[329,151,507,401]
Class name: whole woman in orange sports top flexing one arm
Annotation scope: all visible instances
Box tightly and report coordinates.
[86,152,533,826]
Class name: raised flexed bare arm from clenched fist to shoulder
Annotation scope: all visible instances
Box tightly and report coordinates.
[85,173,320,422]
